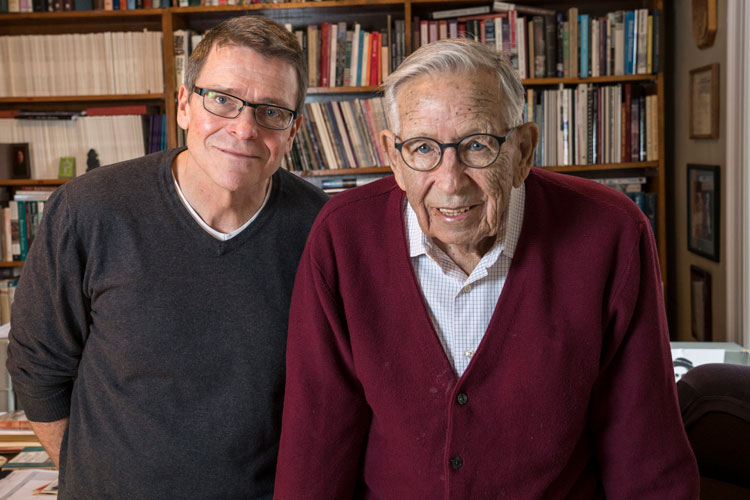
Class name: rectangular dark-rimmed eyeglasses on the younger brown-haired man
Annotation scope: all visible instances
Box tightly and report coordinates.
[193,87,297,130]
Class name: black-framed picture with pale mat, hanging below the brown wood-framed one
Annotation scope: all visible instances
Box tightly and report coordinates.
[687,164,721,262]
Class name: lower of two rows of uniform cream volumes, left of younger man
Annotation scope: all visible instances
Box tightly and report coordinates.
[0,115,148,179]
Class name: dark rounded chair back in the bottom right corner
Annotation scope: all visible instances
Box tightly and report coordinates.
[677,363,750,500]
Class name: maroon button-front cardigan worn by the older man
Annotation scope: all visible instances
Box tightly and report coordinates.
[274,169,698,500]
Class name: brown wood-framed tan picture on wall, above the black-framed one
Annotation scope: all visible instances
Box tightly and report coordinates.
[690,63,719,139]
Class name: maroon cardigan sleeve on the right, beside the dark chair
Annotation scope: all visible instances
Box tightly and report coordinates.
[590,222,699,499]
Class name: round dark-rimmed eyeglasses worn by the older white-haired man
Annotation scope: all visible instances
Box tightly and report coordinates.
[396,128,515,172]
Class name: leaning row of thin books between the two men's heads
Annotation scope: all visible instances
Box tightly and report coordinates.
[282,97,388,171]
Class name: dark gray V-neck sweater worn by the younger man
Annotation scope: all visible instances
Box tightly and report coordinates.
[8,150,327,500]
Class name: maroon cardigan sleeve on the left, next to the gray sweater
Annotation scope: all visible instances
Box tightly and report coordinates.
[274,224,371,500]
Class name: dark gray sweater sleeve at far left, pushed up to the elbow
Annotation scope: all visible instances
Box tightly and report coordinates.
[7,188,90,422]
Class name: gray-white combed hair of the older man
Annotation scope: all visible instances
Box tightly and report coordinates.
[383,38,524,133]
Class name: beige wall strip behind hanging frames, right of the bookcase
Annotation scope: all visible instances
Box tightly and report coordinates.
[665,0,727,341]
